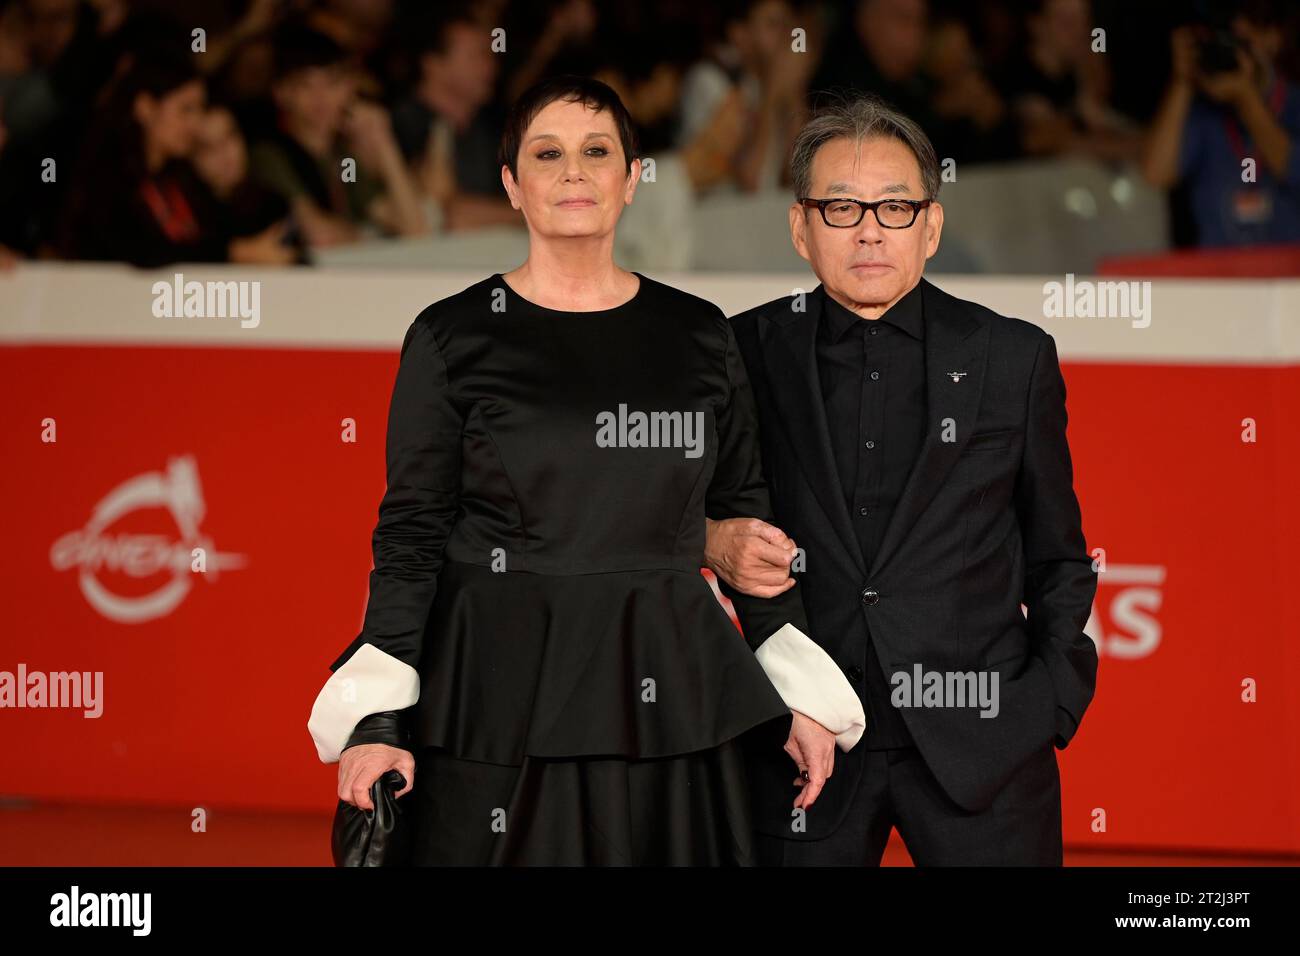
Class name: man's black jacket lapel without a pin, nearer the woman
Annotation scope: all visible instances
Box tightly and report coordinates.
[761,286,867,575]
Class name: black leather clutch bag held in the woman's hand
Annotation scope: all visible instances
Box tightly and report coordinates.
[330,710,411,866]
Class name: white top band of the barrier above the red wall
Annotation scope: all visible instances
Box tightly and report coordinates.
[0,263,1300,365]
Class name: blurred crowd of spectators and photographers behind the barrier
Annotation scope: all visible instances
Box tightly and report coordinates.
[0,0,1300,267]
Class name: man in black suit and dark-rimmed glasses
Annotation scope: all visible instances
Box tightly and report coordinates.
[706,98,1097,865]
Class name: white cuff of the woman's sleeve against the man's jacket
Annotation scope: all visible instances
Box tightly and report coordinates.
[754,623,867,752]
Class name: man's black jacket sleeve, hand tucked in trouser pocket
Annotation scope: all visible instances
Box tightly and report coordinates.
[1015,334,1097,749]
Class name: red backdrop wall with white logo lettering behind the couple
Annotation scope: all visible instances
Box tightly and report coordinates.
[0,300,1300,851]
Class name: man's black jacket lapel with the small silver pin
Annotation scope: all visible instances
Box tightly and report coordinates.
[868,278,988,579]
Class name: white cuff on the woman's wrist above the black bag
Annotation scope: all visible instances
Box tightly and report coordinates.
[307,644,420,763]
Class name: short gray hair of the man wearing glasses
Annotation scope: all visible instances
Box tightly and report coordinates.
[790,94,939,199]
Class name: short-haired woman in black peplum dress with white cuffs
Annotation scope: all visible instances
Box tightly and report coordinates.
[308,77,865,865]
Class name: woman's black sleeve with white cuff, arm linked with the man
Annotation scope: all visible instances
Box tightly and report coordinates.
[705,317,867,750]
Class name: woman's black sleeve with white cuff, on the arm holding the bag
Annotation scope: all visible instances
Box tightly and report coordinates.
[307,319,463,763]
